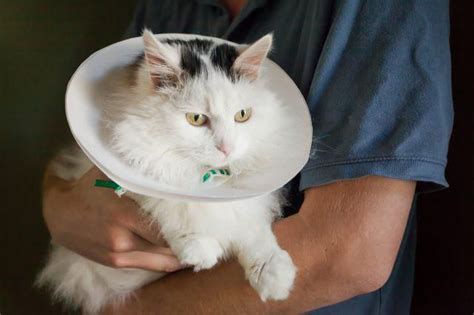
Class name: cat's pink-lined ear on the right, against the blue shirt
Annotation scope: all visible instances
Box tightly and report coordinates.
[232,34,273,81]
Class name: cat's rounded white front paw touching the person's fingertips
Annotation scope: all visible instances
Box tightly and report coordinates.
[178,237,223,271]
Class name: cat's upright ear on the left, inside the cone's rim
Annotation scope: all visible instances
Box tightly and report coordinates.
[143,29,182,88]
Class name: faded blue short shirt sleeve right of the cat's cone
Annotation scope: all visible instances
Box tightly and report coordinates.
[300,0,453,191]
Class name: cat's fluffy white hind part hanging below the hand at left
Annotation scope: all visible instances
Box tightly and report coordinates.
[36,246,164,314]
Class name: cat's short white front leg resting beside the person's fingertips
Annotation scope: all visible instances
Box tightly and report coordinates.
[165,233,224,271]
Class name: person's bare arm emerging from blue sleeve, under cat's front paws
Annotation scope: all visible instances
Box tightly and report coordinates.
[106,176,416,314]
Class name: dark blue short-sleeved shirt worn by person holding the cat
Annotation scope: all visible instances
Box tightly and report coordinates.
[127,0,453,315]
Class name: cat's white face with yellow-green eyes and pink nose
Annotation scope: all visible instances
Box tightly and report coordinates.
[149,74,275,167]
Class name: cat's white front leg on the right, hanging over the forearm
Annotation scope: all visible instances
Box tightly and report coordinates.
[236,227,296,301]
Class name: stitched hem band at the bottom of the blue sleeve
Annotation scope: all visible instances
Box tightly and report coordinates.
[299,157,449,192]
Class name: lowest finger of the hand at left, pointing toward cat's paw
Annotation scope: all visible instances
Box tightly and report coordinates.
[111,251,185,272]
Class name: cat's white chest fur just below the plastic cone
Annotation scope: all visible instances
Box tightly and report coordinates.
[130,192,281,247]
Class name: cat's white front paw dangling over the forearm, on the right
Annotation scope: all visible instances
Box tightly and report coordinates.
[247,250,296,301]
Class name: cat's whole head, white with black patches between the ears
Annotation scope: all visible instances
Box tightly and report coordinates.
[107,30,284,188]
